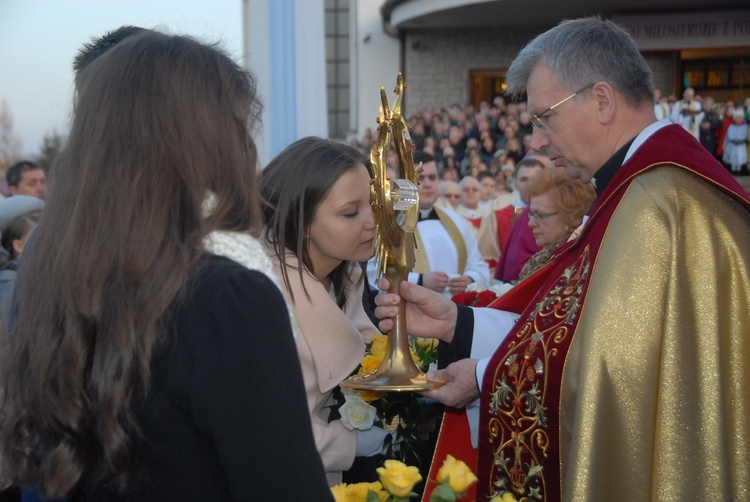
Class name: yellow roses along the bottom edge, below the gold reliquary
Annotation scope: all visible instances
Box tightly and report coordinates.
[331,455,478,502]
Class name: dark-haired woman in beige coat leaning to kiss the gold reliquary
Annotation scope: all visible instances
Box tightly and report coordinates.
[261,137,387,485]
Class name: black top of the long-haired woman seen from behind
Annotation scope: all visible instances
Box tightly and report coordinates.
[68,256,332,501]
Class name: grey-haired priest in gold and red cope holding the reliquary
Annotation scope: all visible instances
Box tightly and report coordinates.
[376,18,750,501]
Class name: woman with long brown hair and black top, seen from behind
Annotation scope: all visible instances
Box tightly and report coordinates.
[0,30,331,501]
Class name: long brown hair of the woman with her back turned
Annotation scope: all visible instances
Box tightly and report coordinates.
[0,30,259,496]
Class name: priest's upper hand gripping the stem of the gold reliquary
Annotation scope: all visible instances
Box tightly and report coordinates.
[375,278,458,343]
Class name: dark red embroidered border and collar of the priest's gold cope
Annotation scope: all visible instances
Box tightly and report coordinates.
[476,125,750,500]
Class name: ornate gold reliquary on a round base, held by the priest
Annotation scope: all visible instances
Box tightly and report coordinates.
[341,73,443,391]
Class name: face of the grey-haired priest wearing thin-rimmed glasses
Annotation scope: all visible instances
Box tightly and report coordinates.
[527,63,611,183]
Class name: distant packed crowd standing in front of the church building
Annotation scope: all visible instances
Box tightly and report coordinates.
[352,83,750,185]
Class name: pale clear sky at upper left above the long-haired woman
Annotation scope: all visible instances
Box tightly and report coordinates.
[0,0,242,157]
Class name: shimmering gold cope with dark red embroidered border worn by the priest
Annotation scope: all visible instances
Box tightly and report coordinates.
[476,125,750,501]
